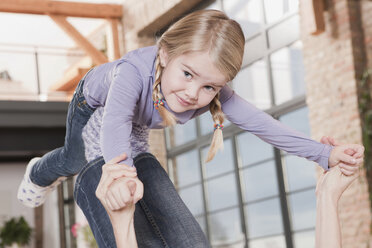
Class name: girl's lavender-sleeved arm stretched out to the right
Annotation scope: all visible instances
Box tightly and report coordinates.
[220,86,362,170]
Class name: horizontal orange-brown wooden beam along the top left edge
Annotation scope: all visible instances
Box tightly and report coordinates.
[0,0,123,19]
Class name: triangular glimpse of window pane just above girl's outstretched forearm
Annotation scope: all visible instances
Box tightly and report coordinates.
[279,107,311,136]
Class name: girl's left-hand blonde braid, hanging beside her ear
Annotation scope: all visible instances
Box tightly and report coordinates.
[152,53,176,126]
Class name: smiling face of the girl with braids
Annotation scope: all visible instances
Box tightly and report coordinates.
[159,49,227,113]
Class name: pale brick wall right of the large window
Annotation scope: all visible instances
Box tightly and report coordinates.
[300,0,372,248]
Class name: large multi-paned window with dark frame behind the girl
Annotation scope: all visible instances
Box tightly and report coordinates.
[166,0,316,248]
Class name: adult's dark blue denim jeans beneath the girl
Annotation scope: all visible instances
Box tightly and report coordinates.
[74,153,210,248]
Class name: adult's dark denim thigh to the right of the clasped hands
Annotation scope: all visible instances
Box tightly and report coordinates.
[134,153,210,248]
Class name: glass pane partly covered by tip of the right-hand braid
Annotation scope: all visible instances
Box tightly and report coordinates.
[203,139,234,178]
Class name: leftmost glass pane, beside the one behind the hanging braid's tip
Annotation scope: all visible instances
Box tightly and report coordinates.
[172,150,200,187]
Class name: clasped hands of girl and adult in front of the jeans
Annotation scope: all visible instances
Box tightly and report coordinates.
[96,154,143,214]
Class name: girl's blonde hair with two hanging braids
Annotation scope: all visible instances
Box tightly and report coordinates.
[152,10,245,162]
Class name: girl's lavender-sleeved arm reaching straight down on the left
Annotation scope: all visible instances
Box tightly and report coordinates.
[100,61,143,166]
